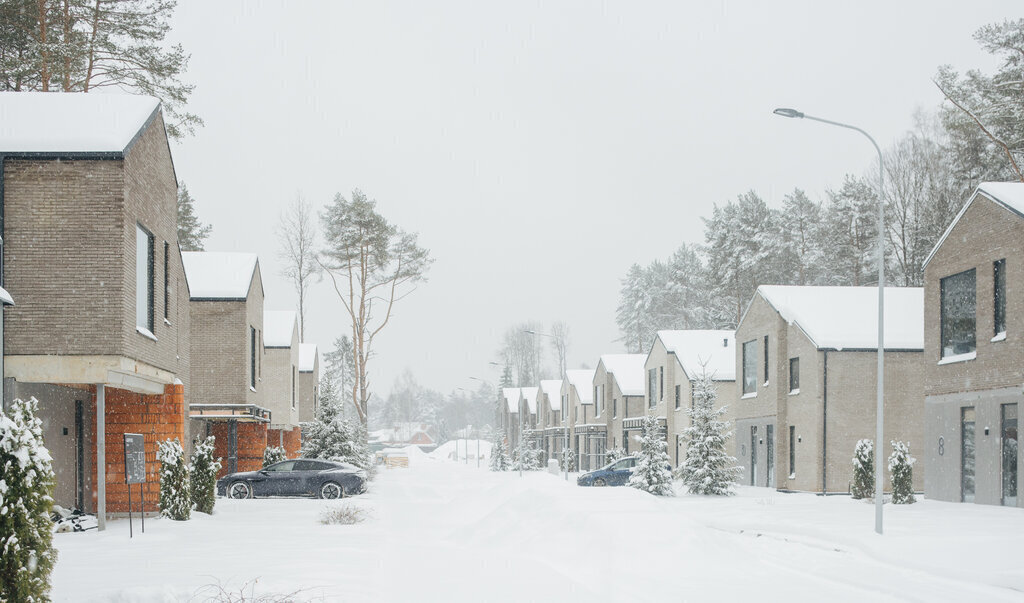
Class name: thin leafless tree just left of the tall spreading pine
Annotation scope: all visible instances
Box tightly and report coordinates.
[278,195,321,341]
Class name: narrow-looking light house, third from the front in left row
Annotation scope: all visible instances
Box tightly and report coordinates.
[263,310,302,459]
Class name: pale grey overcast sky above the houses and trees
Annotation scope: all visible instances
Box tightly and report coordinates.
[171,0,1019,395]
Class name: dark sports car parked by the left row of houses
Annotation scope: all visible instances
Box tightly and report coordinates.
[217,459,367,499]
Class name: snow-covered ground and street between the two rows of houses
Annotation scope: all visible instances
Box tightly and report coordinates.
[52,455,1024,601]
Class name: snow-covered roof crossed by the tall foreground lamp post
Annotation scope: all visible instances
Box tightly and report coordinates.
[753,285,925,350]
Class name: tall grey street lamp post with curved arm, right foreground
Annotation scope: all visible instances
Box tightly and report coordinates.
[773,109,886,534]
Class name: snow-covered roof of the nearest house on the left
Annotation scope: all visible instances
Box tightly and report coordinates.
[0,92,160,153]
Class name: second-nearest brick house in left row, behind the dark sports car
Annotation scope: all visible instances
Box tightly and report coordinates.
[181,252,270,476]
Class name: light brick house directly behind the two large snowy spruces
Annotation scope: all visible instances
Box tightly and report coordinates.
[641,330,736,467]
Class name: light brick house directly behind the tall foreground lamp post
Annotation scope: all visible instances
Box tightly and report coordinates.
[732,286,924,493]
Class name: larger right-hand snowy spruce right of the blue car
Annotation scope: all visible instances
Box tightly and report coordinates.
[677,372,741,497]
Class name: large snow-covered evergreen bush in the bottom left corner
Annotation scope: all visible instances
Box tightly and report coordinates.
[0,398,57,601]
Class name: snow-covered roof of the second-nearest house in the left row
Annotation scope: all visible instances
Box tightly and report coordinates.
[181,251,259,300]
